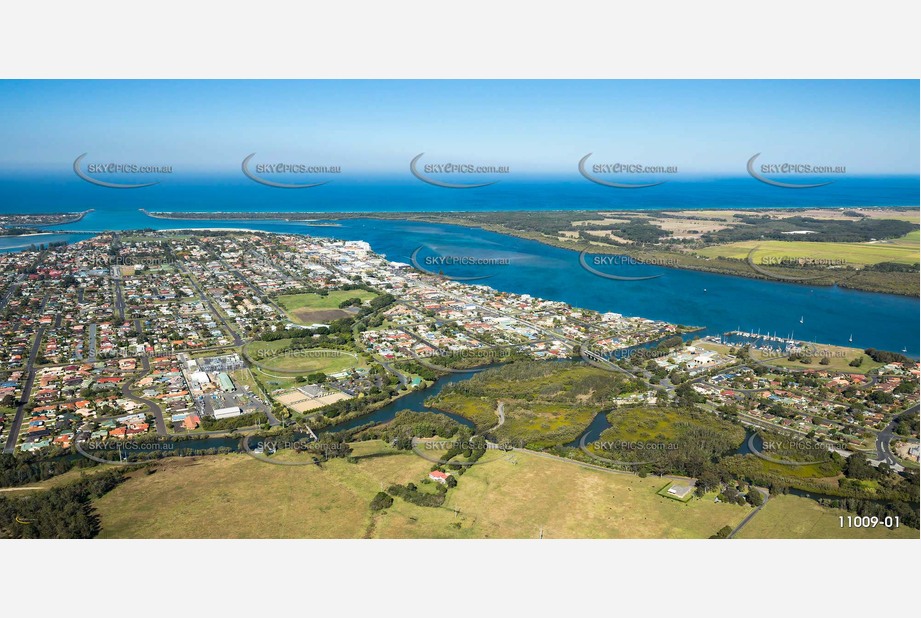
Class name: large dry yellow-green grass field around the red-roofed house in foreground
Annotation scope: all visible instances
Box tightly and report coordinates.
[95,441,750,538]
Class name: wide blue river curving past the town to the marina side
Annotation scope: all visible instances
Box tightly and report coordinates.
[25,209,919,358]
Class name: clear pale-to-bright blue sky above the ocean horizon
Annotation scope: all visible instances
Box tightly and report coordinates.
[0,80,919,175]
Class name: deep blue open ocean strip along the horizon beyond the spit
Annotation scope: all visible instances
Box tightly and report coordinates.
[0,172,919,217]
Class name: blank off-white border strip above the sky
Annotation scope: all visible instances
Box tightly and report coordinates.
[0,0,921,79]
